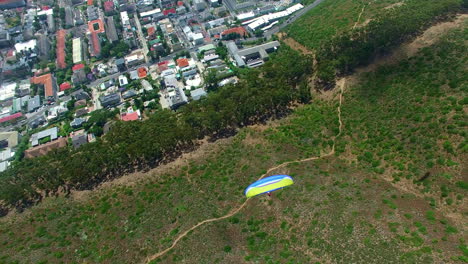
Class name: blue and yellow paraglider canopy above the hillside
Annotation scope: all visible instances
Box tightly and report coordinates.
[244,175,294,198]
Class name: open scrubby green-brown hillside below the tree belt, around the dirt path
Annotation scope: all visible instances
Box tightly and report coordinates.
[0,24,468,263]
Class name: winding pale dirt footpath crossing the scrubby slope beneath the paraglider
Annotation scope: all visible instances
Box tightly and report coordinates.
[145,83,346,263]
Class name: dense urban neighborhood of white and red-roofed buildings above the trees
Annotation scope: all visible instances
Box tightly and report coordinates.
[0,0,305,172]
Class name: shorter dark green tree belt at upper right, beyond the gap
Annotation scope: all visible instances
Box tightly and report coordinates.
[316,0,462,84]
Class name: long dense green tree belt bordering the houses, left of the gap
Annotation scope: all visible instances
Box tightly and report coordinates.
[0,47,312,212]
